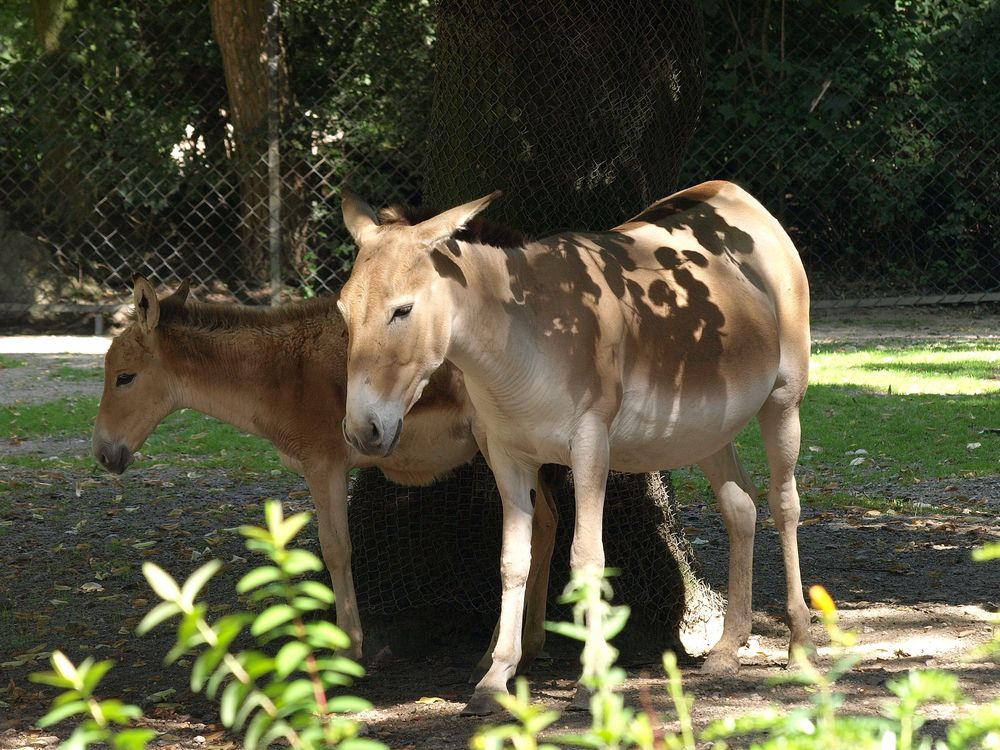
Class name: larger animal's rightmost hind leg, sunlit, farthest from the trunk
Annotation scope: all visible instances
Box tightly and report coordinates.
[757,391,813,654]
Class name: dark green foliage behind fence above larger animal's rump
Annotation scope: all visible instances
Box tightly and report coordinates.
[682,0,1000,297]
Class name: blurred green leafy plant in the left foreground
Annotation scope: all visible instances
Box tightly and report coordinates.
[33,501,383,750]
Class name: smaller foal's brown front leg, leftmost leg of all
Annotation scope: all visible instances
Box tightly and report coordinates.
[305,465,364,660]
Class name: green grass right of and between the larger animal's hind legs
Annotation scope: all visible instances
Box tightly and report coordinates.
[675,342,1000,508]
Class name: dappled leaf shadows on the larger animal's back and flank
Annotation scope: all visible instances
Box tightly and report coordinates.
[492,187,777,429]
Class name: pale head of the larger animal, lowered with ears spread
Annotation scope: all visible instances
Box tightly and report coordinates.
[337,190,499,455]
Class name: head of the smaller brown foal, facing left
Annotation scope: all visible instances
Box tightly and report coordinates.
[92,276,188,474]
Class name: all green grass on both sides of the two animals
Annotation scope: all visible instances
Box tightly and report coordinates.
[7,341,1000,507]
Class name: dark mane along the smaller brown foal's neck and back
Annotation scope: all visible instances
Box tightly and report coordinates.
[150,295,337,331]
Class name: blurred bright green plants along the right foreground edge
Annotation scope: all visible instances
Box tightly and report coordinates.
[472,568,1000,750]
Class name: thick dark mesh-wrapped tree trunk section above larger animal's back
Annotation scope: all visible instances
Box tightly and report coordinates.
[427,0,704,233]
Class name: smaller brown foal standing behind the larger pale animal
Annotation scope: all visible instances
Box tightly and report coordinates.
[93,276,555,671]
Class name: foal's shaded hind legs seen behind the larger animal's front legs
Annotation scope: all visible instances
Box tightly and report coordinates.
[469,477,559,683]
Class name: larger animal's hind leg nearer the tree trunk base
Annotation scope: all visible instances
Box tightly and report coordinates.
[699,443,757,674]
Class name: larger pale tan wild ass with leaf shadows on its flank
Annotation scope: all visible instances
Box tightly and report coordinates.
[338,182,810,713]
